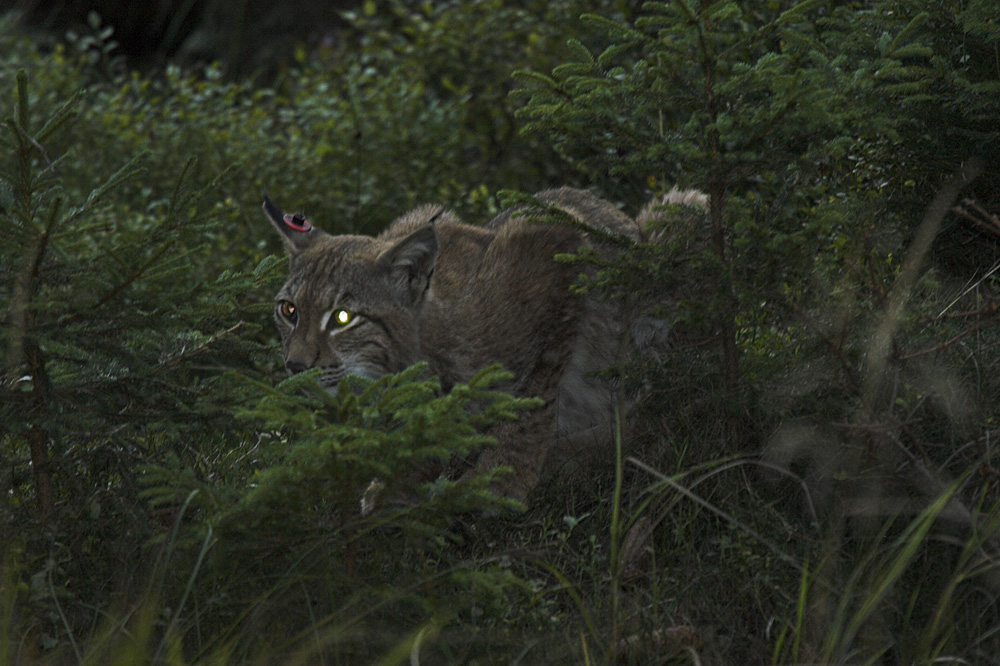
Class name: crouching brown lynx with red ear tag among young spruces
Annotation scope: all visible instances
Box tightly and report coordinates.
[264,188,672,501]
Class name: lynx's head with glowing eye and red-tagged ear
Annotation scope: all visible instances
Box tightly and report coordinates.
[264,197,438,389]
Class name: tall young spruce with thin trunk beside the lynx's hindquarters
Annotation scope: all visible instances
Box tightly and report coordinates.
[519,2,876,408]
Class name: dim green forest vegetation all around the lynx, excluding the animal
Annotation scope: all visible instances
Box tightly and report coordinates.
[0,0,1000,665]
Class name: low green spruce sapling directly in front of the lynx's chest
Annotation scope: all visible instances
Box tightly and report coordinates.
[134,365,535,661]
